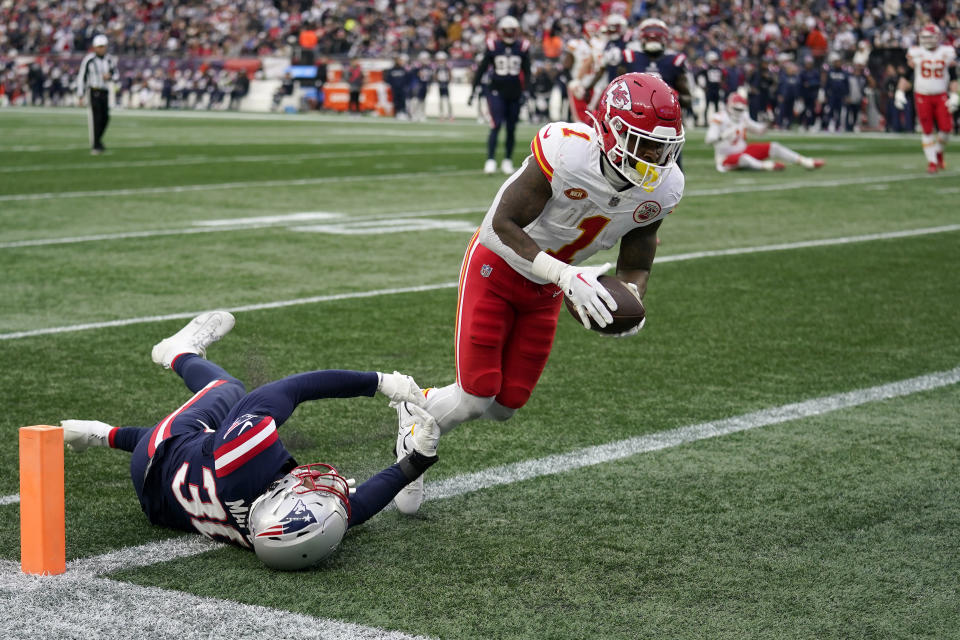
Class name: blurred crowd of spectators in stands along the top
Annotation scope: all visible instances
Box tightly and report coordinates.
[0,0,960,130]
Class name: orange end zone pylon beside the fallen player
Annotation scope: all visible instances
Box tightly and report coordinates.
[20,425,67,575]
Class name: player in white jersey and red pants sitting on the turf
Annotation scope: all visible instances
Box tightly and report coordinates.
[706,92,824,172]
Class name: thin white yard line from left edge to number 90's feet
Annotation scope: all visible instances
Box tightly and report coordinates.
[0,169,477,202]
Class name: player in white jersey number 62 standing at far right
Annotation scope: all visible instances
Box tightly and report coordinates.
[894,24,960,173]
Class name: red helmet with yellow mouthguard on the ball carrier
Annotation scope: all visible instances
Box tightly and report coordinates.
[589,73,684,191]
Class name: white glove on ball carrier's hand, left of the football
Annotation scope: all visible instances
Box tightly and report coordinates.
[533,251,617,329]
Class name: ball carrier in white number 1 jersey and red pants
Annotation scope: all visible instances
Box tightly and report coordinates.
[394,73,684,513]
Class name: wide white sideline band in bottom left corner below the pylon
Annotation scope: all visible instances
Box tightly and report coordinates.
[0,561,423,640]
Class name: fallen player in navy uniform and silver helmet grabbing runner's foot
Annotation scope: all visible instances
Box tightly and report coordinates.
[61,311,440,570]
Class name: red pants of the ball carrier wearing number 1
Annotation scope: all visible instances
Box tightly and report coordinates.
[454,235,563,409]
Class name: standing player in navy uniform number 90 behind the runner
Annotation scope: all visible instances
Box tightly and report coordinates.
[467,16,530,175]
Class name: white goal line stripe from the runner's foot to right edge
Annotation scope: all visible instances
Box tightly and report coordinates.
[426,367,960,500]
